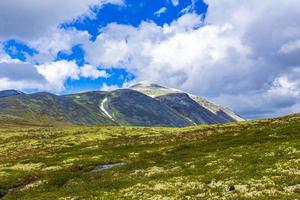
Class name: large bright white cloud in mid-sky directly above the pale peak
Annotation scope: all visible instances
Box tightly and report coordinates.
[85,14,250,93]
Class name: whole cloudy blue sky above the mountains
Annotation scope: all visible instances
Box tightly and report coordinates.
[0,0,300,119]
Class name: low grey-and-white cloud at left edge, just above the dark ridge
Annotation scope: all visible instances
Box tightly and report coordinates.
[0,59,109,91]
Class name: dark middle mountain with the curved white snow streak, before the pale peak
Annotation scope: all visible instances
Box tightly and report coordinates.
[66,89,191,127]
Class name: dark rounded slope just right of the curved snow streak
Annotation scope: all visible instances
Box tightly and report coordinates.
[104,89,191,127]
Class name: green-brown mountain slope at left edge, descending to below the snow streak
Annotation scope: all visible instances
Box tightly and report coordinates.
[0,92,114,124]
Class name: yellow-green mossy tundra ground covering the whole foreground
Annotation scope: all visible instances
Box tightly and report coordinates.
[0,115,300,199]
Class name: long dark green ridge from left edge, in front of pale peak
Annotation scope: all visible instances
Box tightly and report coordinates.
[0,89,193,127]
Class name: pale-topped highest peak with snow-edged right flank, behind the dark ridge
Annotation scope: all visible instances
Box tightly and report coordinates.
[130,82,244,124]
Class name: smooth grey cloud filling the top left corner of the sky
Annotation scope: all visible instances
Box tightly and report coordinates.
[0,0,123,41]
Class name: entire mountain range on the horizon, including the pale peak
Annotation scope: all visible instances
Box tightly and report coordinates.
[0,82,243,127]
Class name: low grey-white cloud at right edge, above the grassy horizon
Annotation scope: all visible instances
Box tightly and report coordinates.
[213,75,300,118]
